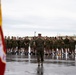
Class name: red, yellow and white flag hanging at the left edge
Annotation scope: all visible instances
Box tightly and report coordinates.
[0,0,6,75]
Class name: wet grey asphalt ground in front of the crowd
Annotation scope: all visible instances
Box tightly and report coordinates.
[5,55,76,75]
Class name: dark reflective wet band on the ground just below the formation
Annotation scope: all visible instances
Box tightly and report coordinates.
[7,55,76,66]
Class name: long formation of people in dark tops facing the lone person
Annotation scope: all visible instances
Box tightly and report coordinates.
[5,36,76,56]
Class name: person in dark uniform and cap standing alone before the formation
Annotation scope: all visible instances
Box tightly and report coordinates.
[35,34,44,66]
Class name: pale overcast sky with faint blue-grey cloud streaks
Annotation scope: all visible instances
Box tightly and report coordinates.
[1,0,76,36]
